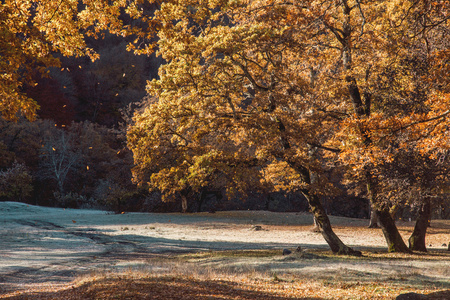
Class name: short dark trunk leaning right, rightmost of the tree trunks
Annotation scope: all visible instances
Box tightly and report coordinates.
[408,199,431,252]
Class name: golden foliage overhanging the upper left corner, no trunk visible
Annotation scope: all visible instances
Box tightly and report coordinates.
[0,0,153,119]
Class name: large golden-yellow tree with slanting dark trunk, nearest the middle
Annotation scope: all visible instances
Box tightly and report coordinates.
[128,1,359,254]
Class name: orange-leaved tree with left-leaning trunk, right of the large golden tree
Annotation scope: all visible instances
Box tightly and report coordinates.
[325,1,448,252]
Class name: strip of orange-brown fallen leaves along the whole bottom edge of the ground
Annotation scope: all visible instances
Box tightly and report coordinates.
[0,274,450,300]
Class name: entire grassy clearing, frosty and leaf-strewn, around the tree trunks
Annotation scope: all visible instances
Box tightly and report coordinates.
[0,202,450,300]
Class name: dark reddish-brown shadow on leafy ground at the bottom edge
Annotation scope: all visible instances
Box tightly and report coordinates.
[4,276,321,300]
